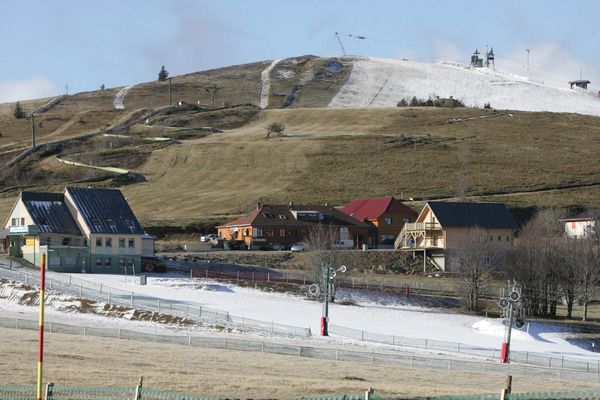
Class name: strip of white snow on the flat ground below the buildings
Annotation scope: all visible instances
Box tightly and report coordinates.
[0,273,600,360]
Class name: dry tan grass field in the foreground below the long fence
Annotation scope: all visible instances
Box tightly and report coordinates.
[0,328,600,399]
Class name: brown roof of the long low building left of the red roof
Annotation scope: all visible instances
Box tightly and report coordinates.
[221,204,369,228]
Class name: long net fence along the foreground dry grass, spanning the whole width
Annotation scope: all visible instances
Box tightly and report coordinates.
[0,318,600,382]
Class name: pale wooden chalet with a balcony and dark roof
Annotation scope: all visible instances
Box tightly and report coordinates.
[395,201,517,271]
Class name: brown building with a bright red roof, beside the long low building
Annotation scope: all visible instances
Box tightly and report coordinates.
[341,196,417,248]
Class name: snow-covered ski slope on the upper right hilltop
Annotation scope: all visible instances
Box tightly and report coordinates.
[329,57,600,115]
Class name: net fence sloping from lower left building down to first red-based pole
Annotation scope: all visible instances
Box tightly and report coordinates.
[0,266,311,337]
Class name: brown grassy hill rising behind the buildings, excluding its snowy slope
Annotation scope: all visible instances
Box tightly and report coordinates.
[0,57,600,228]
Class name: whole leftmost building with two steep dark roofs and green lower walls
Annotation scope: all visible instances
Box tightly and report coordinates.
[5,188,144,273]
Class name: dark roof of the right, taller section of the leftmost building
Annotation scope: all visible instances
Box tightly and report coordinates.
[66,188,144,235]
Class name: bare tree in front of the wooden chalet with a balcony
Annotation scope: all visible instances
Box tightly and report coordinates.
[458,228,497,311]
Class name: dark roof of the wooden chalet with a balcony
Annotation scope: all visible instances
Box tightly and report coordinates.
[427,201,517,229]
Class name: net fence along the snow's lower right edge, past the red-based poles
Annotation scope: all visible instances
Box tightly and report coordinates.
[329,324,600,373]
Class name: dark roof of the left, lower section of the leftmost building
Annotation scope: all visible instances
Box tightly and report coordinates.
[21,192,81,235]
